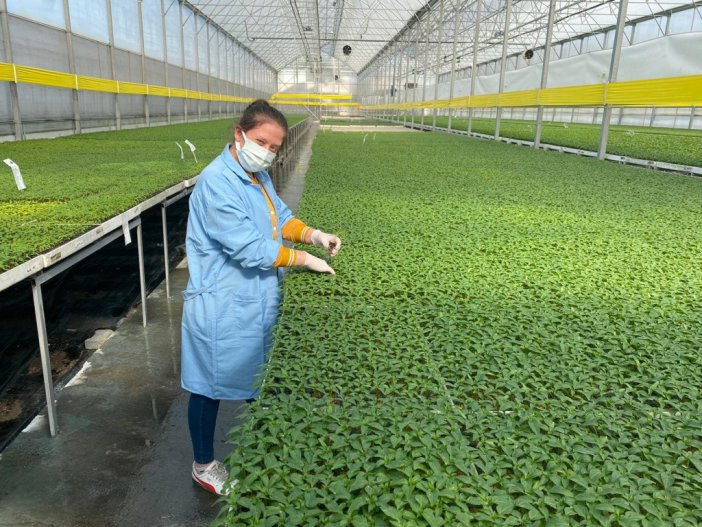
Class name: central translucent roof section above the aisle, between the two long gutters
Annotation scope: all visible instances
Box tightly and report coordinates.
[188,0,433,71]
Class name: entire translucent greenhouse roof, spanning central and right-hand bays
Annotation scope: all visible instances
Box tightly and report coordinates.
[189,0,699,72]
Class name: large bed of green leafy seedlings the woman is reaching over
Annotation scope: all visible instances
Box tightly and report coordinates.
[216,134,702,526]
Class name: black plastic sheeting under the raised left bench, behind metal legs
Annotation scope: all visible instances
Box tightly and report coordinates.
[0,198,188,451]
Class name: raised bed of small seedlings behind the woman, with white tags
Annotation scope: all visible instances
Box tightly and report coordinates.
[0,116,304,272]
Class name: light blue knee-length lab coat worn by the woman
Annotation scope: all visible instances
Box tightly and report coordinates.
[181,145,293,400]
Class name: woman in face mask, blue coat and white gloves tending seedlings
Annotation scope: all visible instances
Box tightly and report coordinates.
[181,100,341,494]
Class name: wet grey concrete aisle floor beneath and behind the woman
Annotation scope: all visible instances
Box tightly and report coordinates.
[0,132,314,527]
